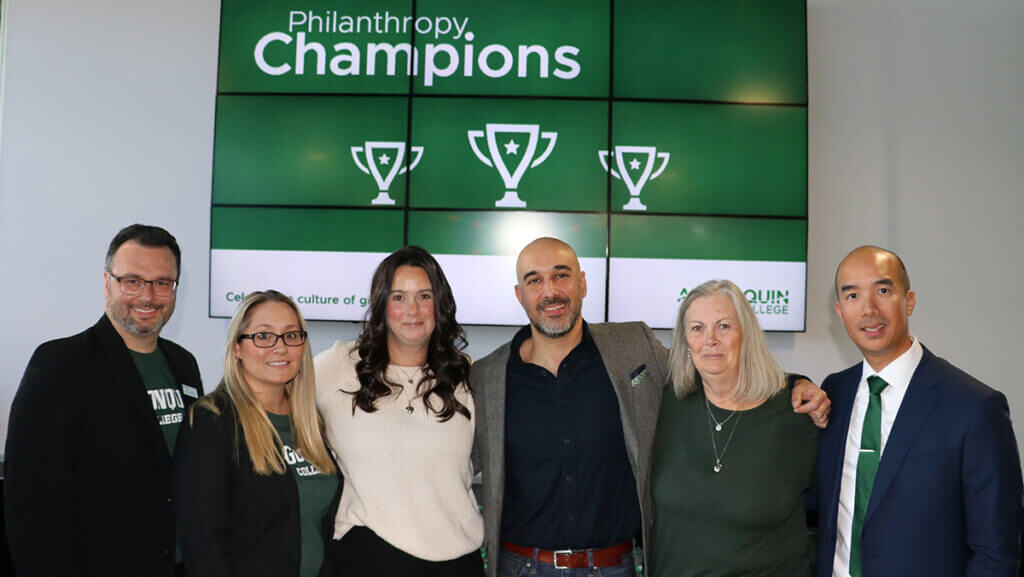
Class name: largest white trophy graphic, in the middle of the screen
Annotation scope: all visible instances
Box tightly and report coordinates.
[467,123,558,208]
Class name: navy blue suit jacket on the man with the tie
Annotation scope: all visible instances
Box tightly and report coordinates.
[817,348,1024,577]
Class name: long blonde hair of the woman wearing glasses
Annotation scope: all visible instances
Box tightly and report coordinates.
[188,290,335,476]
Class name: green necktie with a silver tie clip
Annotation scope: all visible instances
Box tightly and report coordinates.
[850,375,889,577]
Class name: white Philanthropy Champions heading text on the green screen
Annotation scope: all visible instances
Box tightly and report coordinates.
[253,10,581,86]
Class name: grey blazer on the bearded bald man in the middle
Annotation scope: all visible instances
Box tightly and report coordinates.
[469,323,669,577]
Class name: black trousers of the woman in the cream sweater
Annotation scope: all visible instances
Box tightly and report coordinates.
[325,527,483,577]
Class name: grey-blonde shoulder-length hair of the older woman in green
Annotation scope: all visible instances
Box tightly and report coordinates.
[669,280,785,403]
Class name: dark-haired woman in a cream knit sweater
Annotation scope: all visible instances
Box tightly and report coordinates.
[315,246,483,577]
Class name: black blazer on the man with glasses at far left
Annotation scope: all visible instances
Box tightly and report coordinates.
[4,316,202,577]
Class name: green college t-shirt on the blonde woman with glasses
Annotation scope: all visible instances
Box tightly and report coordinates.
[266,412,338,577]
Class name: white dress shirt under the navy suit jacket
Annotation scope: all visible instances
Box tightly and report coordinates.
[833,337,925,577]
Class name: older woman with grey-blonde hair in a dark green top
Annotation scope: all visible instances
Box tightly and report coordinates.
[649,281,818,577]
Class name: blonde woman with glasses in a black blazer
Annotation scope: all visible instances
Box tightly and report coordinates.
[174,290,339,577]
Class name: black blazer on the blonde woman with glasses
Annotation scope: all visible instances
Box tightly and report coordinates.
[173,390,341,577]
